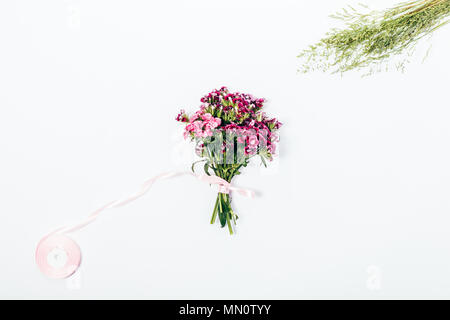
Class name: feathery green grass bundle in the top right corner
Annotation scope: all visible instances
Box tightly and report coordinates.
[298,0,450,73]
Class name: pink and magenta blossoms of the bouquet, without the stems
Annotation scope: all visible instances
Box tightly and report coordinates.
[176,87,281,160]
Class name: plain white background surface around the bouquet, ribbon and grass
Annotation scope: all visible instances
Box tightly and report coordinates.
[0,0,450,299]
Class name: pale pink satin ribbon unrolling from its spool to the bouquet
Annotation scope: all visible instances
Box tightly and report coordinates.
[36,171,255,278]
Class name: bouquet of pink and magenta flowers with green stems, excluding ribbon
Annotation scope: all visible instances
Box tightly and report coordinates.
[176,87,281,234]
